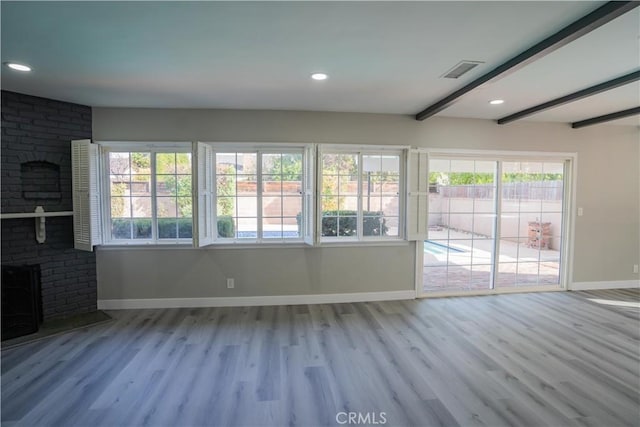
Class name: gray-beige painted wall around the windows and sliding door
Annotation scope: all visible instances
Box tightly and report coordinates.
[93,108,640,299]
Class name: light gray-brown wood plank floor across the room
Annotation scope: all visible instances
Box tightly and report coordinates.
[2,289,640,427]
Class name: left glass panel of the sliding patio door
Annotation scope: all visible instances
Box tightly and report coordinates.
[423,159,497,292]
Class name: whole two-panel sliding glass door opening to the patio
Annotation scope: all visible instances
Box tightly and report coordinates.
[422,156,566,295]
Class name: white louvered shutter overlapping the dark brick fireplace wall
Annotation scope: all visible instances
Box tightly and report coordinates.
[71,139,102,251]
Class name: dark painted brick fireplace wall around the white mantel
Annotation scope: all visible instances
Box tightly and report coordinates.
[1,91,97,319]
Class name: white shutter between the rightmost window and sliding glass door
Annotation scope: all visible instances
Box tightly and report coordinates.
[407,150,429,240]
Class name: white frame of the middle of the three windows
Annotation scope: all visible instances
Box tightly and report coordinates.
[194,142,316,247]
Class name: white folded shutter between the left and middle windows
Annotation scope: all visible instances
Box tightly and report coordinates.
[196,142,217,247]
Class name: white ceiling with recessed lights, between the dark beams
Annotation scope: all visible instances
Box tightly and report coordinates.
[1,1,640,125]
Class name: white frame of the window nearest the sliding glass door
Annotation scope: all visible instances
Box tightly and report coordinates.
[316,144,408,246]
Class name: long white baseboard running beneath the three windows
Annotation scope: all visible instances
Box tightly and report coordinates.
[98,290,416,310]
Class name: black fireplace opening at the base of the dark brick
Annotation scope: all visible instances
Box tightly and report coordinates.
[2,265,42,341]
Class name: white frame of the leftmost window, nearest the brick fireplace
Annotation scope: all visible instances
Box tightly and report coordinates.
[97,141,197,246]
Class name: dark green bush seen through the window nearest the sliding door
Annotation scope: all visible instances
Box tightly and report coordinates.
[314,211,389,236]
